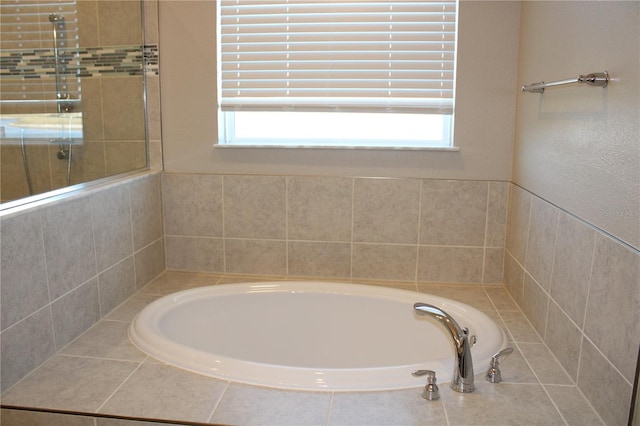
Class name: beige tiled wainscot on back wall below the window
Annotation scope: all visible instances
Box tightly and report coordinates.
[163,173,508,283]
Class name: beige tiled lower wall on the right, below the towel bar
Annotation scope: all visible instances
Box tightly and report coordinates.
[505,185,640,425]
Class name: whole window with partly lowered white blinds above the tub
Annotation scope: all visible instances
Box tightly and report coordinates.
[218,0,457,148]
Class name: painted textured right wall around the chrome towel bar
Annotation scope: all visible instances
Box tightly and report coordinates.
[513,1,640,248]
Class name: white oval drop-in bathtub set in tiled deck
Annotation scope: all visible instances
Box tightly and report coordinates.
[129,281,506,391]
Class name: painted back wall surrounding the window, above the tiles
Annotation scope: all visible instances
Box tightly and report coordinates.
[159,0,520,180]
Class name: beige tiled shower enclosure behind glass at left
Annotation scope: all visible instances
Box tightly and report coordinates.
[0,0,147,203]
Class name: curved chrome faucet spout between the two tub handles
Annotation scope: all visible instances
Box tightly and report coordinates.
[413,302,475,392]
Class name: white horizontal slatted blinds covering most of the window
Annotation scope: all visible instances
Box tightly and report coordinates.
[218,0,456,114]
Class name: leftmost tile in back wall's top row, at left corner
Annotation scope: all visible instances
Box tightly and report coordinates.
[162,174,222,237]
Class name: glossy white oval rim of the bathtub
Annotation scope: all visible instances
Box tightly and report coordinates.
[128,281,508,392]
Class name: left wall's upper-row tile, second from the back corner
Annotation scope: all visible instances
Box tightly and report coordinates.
[91,186,133,271]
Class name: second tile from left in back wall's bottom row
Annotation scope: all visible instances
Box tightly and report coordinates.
[224,239,287,275]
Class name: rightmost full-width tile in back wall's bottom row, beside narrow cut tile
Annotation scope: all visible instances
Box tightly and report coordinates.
[418,246,484,283]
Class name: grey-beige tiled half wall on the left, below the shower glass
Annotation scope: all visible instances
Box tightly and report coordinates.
[0,174,165,390]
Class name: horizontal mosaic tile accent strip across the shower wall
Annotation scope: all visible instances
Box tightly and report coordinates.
[0,45,159,79]
